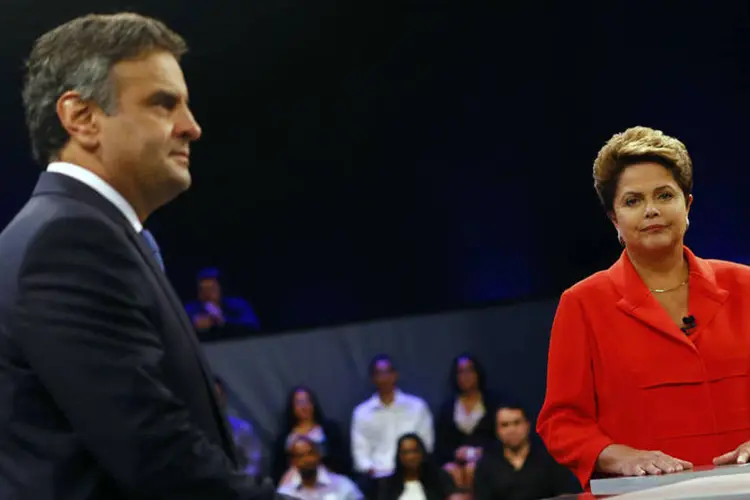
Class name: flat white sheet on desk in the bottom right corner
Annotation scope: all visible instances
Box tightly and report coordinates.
[614,474,750,500]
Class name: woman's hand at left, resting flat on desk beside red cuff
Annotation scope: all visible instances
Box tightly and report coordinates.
[596,444,693,476]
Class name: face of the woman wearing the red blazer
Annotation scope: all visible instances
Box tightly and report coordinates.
[612,162,693,253]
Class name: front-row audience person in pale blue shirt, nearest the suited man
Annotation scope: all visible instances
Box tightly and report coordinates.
[278,436,363,500]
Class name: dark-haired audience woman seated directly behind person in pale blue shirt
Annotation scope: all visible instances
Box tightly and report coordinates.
[271,386,351,484]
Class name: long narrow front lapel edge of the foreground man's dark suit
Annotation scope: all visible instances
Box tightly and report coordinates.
[128,227,238,465]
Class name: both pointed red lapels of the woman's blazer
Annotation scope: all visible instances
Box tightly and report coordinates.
[608,247,729,345]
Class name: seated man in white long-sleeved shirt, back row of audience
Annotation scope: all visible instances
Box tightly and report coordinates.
[351,354,435,497]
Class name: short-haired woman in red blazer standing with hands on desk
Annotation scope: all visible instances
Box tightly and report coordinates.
[537,127,750,487]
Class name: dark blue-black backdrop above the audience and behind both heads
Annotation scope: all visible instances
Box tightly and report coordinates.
[0,0,750,331]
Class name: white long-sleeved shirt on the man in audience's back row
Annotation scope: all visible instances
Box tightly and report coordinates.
[352,390,435,477]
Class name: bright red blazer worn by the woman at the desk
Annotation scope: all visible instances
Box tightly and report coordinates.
[537,248,750,487]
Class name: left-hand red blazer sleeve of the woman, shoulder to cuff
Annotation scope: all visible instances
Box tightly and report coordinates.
[537,290,613,489]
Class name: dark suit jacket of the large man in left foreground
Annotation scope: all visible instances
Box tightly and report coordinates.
[0,173,272,500]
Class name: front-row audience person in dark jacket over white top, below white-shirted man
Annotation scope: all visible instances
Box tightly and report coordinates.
[377,433,456,500]
